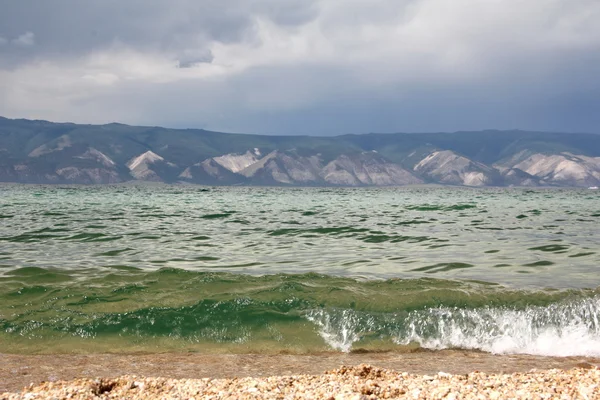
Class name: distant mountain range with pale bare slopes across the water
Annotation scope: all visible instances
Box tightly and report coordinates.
[0,117,600,187]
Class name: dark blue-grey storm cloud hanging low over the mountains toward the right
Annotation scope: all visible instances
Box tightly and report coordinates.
[129,58,600,135]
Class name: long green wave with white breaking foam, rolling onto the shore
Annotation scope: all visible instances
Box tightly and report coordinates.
[0,264,600,356]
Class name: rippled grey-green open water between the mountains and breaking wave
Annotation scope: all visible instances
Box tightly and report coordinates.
[0,186,600,287]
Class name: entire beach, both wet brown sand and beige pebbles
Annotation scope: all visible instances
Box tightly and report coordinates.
[0,350,600,399]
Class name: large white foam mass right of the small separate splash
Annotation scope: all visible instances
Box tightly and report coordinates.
[395,298,600,357]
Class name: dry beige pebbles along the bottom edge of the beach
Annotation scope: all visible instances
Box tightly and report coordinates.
[0,364,600,400]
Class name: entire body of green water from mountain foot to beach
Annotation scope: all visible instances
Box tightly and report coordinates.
[0,185,600,356]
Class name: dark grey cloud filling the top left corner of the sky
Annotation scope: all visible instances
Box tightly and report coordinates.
[0,0,315,67]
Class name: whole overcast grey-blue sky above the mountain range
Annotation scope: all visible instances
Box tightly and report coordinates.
[0,0,600,135]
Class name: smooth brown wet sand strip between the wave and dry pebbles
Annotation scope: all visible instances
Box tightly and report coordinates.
[0,350,600,393]
